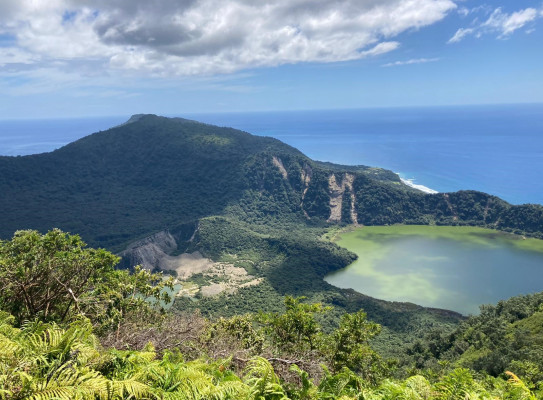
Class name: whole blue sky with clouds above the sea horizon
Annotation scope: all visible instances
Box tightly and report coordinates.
[0,0,543,119]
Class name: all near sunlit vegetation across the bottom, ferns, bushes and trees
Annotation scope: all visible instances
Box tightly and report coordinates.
[0,230,543,400]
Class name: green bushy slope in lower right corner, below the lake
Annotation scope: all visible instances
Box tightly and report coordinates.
[408,293,543,387]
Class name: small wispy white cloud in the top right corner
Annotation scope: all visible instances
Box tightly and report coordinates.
[448,7,543,43]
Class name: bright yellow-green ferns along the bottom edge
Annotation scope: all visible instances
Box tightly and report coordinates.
[0,312,536,400]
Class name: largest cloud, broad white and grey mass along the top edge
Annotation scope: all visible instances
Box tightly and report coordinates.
[0,0,456,76]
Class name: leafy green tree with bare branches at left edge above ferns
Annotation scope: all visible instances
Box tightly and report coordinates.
[0,229,172,327]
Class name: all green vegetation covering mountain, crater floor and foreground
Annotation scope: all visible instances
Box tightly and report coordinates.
[0,115,543,399]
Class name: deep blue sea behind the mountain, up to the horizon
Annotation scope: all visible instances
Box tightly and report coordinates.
[0,104,543,204]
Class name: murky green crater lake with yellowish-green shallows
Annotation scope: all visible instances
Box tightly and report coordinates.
[325,225,543,315]
